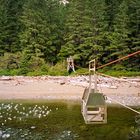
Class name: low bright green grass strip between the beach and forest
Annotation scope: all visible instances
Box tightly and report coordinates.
[0,65,140,77]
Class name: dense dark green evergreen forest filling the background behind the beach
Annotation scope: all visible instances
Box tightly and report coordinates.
[0,0,140,75]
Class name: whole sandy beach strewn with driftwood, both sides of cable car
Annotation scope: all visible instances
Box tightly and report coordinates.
[0,76,140,105]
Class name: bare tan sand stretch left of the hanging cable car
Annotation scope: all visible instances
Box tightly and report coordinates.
[0,77,84,99]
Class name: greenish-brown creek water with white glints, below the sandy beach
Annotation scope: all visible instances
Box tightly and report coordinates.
[0,101,136,140]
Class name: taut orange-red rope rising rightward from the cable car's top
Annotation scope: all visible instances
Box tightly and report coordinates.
[96,51,140,69]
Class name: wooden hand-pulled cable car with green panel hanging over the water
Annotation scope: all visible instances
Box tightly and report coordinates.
[81,60,107,124]
